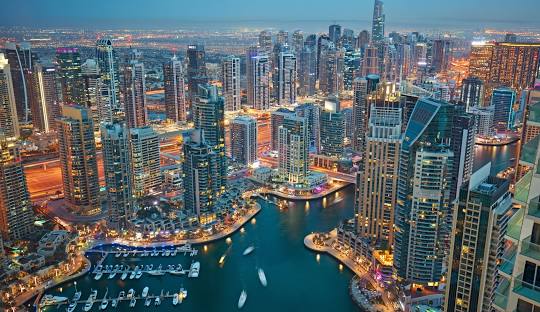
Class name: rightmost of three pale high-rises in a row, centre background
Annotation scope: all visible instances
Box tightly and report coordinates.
[278,52,297,105]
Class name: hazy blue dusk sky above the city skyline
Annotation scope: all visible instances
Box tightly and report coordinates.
[0,0,540,28]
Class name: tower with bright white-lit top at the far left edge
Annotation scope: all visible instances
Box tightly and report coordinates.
[0,53,20,137]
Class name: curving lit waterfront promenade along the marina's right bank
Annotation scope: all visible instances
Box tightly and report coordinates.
[304,229,394,312]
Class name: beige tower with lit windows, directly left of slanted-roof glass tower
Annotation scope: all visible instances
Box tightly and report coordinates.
[355,104,402,250]
